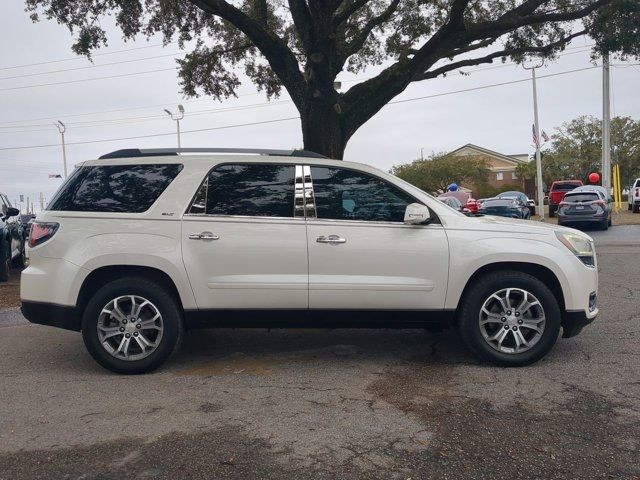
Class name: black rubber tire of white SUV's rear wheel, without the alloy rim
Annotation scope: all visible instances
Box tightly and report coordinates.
[82,277,184,374]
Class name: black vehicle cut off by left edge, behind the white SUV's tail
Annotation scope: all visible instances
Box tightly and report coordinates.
[0,193,25,282]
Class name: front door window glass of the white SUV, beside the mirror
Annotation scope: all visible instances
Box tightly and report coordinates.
[311,167,415,222]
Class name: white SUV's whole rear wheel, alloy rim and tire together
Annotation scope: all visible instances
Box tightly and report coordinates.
[82,277,183,374]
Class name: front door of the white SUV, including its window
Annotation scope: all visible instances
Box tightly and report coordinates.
[307,166,449,310]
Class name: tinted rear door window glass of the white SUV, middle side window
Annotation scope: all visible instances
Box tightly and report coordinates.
[189,163,295,217]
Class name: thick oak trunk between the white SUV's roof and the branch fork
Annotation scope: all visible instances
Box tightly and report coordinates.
[300,99,348,160]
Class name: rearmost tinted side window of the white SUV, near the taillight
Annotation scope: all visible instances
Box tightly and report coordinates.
[48,164,182,213]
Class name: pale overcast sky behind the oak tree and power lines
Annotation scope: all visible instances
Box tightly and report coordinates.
[0,0,640,210]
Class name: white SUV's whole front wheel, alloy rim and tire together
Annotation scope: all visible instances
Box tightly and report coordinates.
[458,271,561,367]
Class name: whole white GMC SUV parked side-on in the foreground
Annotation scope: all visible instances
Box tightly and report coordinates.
[21,149,598,373]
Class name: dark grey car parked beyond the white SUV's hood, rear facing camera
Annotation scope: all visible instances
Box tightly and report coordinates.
[558,185,612,230]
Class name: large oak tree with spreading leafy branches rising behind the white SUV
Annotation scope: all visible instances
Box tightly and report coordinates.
[25,0,640,158]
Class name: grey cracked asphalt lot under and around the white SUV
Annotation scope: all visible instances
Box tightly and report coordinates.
[0,226,640,479]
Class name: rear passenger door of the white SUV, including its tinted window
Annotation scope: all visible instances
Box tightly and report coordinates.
[182,163,308,309]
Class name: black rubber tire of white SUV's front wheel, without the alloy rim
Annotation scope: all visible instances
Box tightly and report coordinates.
[457,270,561,367]
